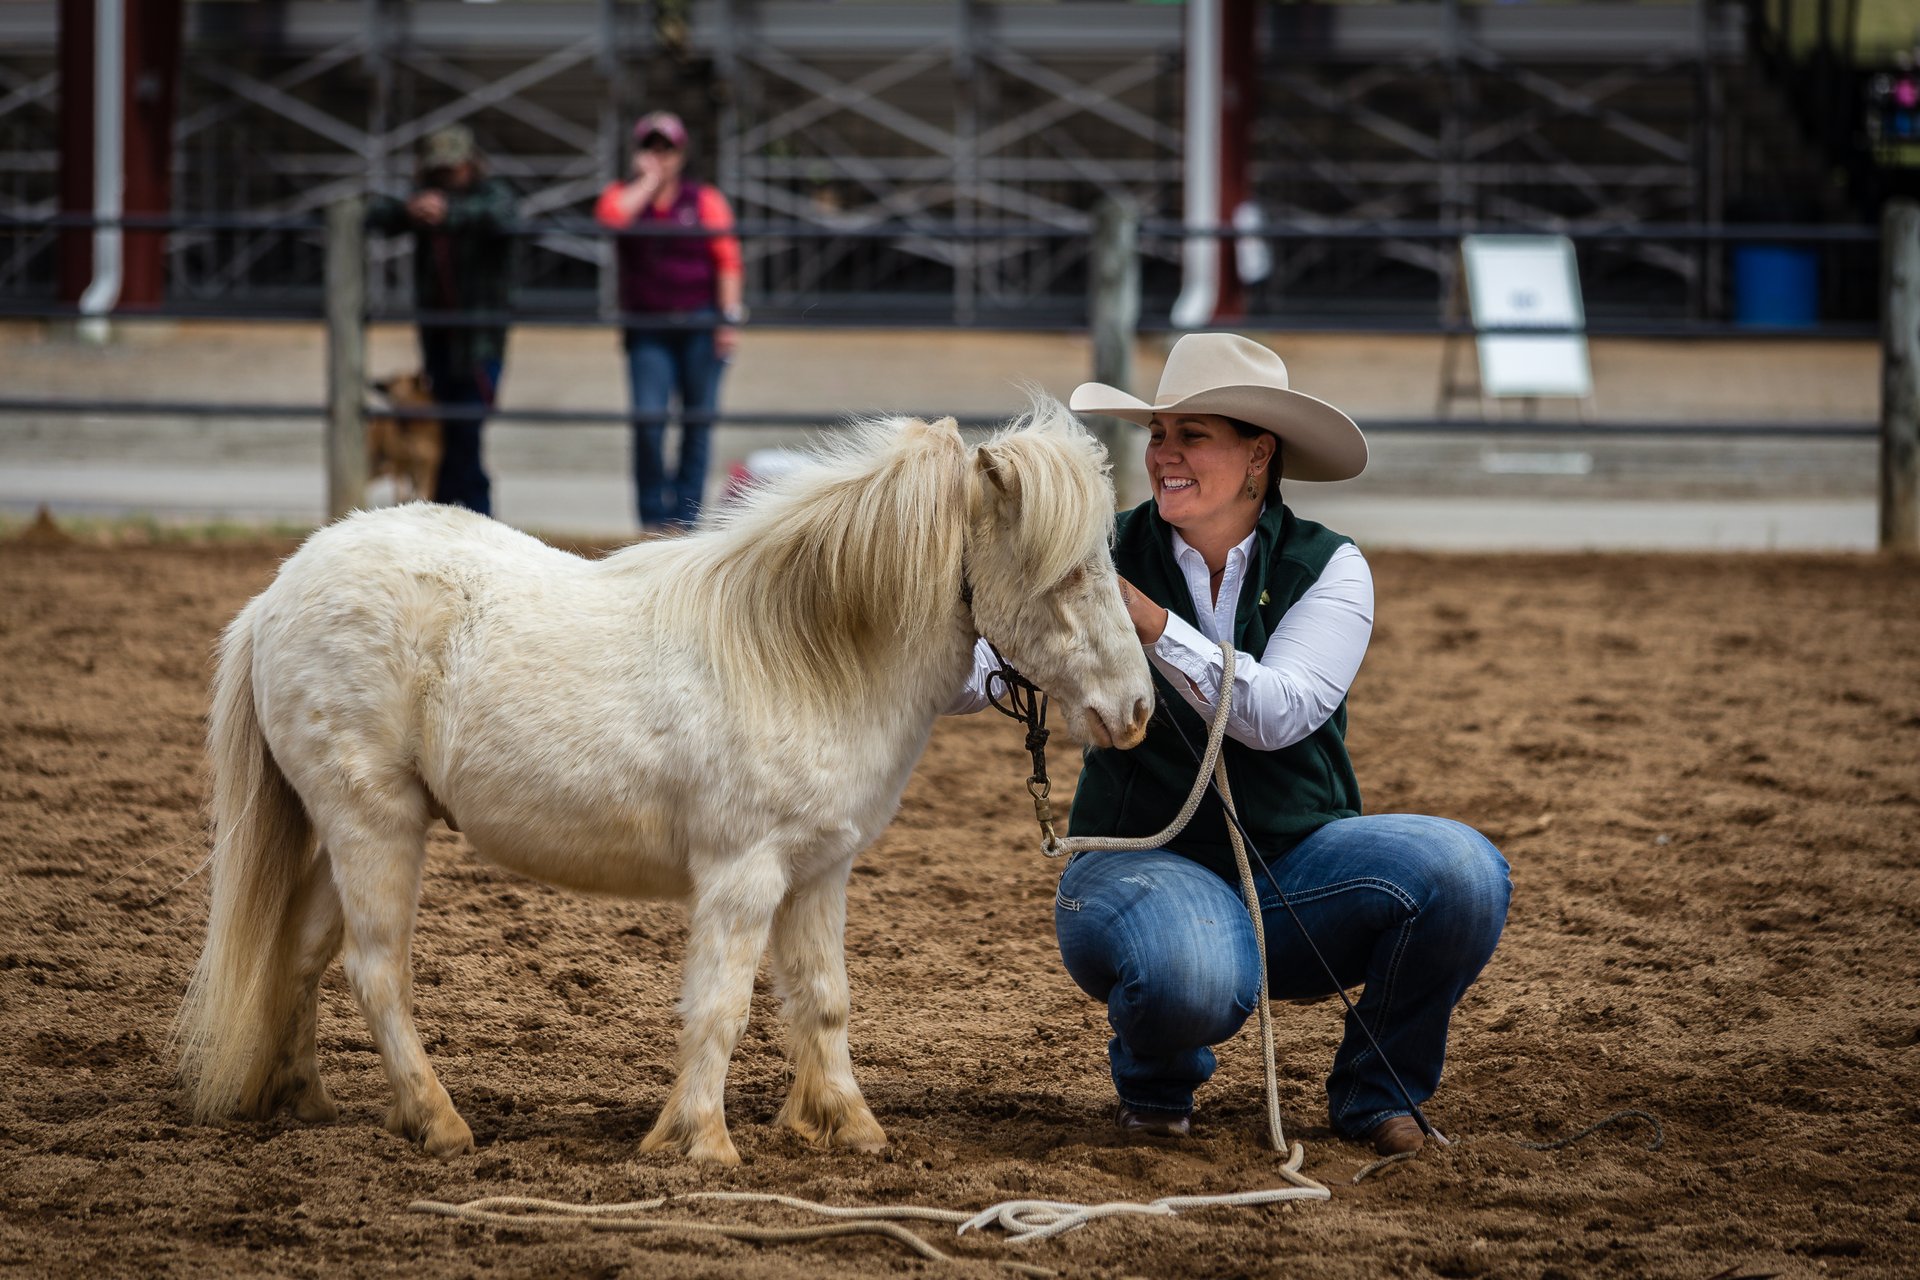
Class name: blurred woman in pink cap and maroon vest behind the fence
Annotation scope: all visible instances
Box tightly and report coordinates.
[593,111,747,528]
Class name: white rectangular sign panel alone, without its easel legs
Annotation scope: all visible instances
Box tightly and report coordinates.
[1459,236,1594,399]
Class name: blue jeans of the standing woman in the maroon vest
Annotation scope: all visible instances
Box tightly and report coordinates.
[626,315,726,526]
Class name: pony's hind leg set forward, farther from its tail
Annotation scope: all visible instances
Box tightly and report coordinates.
[326,821,474,1155]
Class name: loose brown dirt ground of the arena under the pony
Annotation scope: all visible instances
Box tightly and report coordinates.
[0,525,1920,1280]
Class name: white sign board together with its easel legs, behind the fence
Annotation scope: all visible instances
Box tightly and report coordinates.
[1438,236,1594,422]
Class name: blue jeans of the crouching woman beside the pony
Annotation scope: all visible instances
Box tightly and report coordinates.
[1054,814,1511,1138]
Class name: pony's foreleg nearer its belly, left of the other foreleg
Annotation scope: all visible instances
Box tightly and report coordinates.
[639,860,785,1165]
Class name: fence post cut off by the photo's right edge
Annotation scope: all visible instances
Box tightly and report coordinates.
[1880,200,1920,555]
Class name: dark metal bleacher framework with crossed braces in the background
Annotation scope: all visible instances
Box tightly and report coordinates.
[0,0,1896,322]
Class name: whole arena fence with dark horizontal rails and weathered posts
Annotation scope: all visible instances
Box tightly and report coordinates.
[0,200,1920,549]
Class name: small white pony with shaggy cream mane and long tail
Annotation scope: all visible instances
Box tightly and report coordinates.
[177,401,1152,1163]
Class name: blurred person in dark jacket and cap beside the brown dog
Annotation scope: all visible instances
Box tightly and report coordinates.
[367,125,515,516]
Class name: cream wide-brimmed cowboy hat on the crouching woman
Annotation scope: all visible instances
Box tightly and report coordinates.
[1069,334,1367,480]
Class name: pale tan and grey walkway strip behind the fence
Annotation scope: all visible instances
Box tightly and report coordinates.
[0,324,1880,551]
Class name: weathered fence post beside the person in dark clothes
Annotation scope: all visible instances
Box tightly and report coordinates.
[326,196,367,520]
